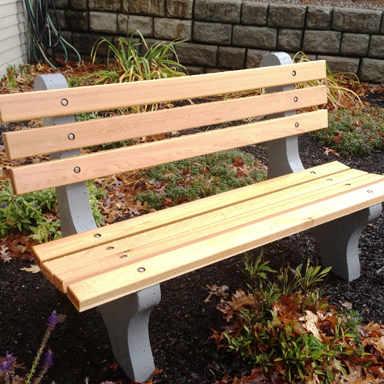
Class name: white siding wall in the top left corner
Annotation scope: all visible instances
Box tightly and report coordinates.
[0,0,27,78]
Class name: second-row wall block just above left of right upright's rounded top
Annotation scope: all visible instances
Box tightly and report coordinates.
[232,25,277,50]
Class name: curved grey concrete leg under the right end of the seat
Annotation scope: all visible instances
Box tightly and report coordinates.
[311,204,382,281]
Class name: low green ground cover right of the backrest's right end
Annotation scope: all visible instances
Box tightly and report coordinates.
[311,109,384,156]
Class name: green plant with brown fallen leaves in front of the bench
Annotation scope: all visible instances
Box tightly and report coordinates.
[213,254,363,383]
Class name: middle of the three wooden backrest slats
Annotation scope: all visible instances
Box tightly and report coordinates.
[3,86,327,159]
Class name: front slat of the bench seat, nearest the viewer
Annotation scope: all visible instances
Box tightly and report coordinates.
[68,182,384,311]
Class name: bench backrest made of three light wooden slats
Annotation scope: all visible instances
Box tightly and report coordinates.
[0,55,327,198]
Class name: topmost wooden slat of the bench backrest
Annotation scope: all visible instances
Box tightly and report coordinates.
[0,61,326,122]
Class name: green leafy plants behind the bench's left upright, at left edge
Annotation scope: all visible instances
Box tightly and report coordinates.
[0,183,103,243]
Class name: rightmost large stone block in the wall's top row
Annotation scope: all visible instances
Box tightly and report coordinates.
[332,8,382,33]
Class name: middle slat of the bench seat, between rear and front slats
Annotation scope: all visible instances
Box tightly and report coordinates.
[43,170,384,292]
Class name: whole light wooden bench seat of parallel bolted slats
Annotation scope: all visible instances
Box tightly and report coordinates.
[34,162,384,311]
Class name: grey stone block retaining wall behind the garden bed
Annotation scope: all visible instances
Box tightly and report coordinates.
[55,0,384,83]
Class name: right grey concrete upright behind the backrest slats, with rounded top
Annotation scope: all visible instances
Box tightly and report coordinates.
[260,52,304,179]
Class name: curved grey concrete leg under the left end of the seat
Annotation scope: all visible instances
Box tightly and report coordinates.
[99,284,161,382]
